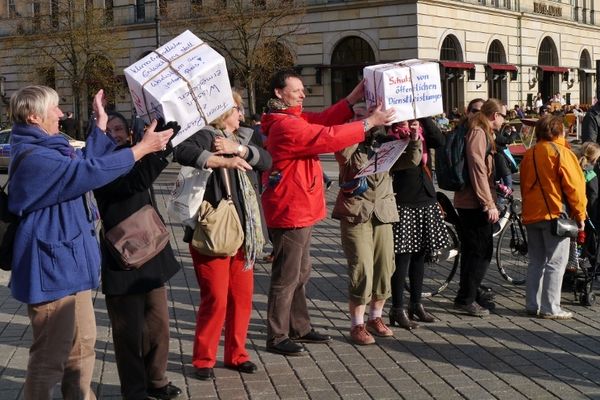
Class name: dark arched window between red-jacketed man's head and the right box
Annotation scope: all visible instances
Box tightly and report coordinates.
[331,36,375,103]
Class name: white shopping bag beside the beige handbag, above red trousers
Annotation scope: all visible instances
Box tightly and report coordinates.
[167,167,212,228]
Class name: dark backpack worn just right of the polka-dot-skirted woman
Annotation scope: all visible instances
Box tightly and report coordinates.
[435,124,469,192]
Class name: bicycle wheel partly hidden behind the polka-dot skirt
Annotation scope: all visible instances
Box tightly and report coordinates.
[422,222,460,297]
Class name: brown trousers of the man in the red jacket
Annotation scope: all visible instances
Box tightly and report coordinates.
[267,226,312,345]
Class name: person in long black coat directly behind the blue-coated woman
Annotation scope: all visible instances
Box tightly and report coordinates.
[94,113,181,400]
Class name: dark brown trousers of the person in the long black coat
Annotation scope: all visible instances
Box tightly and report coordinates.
[106,286,169,400]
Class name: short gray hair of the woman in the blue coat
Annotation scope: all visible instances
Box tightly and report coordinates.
[10,85,59,124]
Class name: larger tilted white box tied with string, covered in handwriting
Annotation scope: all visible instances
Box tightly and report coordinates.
[125,31,235,146]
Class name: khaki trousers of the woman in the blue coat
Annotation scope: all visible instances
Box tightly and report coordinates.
[25,290,96,400]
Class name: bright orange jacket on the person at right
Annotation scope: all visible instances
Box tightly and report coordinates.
[520,138,587,224]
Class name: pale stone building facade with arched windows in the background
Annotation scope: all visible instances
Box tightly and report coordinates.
[0,0,600,122]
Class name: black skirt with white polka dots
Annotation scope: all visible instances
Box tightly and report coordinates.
[393,203,450,254]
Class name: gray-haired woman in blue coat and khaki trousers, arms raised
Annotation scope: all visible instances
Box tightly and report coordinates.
[8,86,173,400]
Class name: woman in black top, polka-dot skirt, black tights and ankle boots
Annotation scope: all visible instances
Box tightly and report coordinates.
[389,118,450,330]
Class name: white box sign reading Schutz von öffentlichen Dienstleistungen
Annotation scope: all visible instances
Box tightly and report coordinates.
[363,59,444,122]
